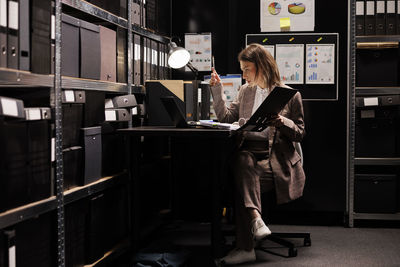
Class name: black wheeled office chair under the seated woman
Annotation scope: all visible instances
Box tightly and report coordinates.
[256,142,311,257]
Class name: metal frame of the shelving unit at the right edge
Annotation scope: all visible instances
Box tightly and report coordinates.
[346,0,400,227]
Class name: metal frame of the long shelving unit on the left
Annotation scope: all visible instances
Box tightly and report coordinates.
[0,0,170,267]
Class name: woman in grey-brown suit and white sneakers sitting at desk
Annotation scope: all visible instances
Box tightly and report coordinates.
[210,44,305,264]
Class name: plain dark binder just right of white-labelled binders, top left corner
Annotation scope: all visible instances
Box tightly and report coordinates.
[19,0,31,71]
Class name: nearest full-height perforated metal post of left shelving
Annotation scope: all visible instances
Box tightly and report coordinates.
[52,0,65,267]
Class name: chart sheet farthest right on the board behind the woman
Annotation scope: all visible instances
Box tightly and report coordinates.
[306,44,335,84]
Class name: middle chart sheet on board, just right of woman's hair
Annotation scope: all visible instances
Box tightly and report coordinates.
[276,44,304,84]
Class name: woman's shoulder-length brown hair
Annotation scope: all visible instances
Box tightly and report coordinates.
[238,44,281,88]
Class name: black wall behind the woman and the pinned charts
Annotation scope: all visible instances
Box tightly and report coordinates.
[172,0,347,212]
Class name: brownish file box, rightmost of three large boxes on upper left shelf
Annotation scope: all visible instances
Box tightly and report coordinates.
[100,26,117,82]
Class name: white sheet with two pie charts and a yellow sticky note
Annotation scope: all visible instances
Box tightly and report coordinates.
[260,0,315,32]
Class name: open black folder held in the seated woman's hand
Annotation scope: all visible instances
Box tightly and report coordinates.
[239,87,298,132]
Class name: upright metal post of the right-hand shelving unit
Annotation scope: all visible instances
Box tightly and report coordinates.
[346,0,356,227]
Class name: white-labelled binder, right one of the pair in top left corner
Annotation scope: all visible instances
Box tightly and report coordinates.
[7,0,19,69]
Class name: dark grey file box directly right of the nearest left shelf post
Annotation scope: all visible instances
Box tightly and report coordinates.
[61,14,80,77]
